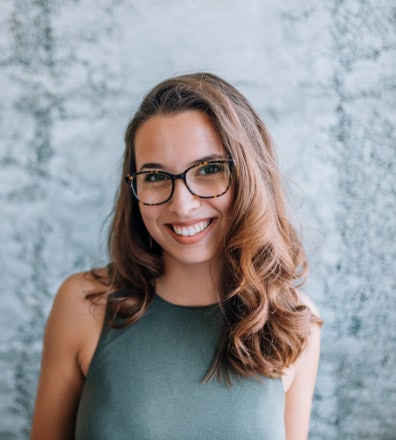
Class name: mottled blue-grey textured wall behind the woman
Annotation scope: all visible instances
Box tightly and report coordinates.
[0,0,396,440]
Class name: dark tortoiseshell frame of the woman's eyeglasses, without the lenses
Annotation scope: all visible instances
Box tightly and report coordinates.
[124,158,235,206]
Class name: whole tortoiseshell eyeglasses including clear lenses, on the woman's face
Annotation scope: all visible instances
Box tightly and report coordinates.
[125,159,234,205]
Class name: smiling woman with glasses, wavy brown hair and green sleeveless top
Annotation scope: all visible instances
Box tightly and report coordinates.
[31,73,321,440]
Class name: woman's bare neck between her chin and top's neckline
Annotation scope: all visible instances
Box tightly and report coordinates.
[156,261,220,306]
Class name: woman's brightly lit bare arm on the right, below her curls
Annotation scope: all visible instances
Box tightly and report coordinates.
[285,298,320,440]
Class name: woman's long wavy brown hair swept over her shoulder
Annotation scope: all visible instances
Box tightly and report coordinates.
[91,73,320,379]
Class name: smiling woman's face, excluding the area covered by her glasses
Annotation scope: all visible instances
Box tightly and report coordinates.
[135,110,233,265]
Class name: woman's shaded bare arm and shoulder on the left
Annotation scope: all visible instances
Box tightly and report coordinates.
[31,274,102,440]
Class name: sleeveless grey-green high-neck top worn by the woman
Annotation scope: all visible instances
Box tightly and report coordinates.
[76,296,285,440]
